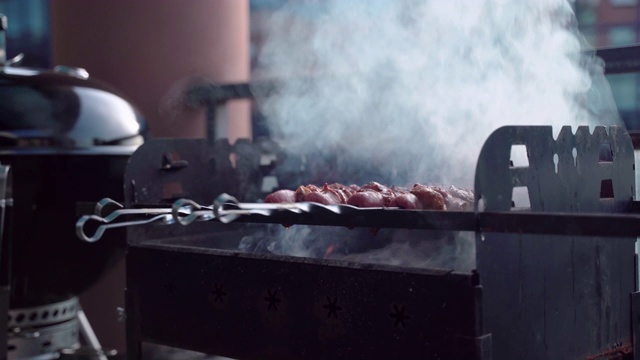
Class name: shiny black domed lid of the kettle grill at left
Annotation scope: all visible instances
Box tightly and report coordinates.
[0,14,147,152]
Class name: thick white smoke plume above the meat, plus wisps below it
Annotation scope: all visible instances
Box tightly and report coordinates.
[248,0,620,269]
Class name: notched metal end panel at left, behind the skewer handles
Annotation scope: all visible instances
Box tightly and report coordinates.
[124,139,268,208]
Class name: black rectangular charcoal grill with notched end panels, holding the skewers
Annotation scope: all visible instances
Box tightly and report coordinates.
[78,48,640,360]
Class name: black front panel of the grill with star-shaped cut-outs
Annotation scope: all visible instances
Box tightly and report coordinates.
[127,246,484,360]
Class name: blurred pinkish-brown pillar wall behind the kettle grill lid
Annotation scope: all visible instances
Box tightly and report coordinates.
[51,0,250,138]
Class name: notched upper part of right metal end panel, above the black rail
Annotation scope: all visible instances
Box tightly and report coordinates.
[476,126,635,212]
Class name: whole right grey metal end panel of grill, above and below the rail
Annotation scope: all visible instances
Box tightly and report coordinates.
[476,126,635,359]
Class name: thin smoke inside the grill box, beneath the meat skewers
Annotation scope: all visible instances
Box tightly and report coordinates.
[239,225,475,271]
